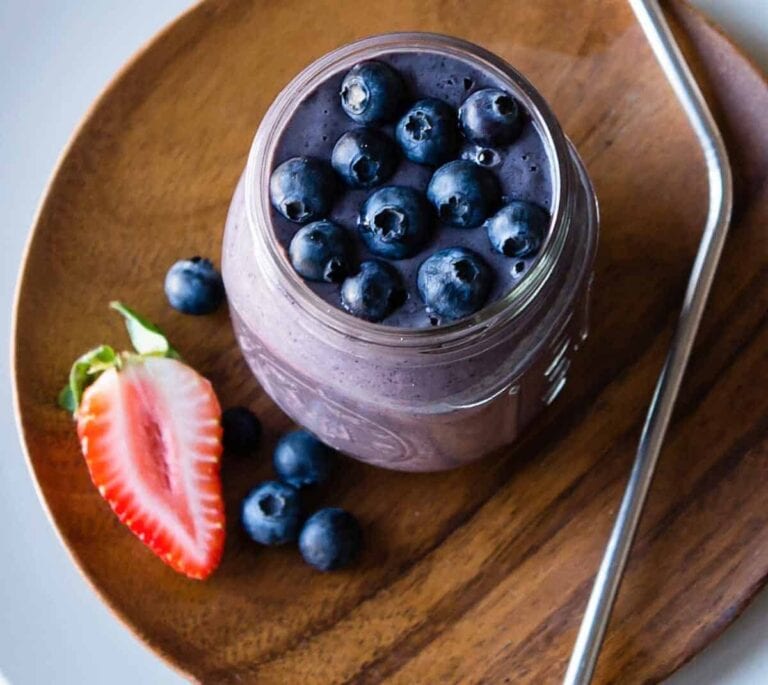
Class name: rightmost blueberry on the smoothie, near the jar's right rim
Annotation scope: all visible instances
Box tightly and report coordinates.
[484,200,549,257]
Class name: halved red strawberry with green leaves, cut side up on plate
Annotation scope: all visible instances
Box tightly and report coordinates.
[64,305,224,579]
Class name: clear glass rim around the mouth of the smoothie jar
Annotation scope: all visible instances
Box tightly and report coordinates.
[245,32,571,349]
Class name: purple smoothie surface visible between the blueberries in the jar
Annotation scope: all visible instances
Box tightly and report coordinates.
[271,51,552,328]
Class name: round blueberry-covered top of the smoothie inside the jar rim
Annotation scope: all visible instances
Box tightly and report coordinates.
[269,49,553,328]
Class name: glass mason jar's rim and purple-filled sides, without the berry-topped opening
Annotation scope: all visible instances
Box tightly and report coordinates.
[222,33,598,471]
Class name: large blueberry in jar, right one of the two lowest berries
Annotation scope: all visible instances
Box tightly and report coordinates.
[417,247,493,320]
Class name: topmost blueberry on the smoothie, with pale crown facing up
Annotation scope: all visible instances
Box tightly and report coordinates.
[339,61,405,124]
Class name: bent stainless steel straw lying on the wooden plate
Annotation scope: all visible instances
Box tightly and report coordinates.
[563,0,733,685]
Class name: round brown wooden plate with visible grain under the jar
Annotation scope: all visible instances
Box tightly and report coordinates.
[14,0,768,685]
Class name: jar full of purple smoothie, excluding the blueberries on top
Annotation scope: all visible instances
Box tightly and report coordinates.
[222,33,598,471]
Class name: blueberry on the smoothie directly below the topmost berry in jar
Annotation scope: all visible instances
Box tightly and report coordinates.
[331,128,397,188]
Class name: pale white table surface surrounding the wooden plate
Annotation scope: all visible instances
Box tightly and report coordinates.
[0,0,768,685]
